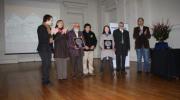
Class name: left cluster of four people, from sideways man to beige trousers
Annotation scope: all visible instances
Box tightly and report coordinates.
[37,15,97,84]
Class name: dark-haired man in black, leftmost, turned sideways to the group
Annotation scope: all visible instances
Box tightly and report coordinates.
[37,15,53,85]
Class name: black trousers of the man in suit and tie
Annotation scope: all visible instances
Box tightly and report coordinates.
[116,53,126,72]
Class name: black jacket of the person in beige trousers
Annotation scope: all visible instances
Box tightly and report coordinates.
[83,31,97,51]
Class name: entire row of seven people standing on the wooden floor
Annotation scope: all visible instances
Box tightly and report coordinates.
[37,14,151,84]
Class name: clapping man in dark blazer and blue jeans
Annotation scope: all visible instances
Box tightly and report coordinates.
[133,17,151,73]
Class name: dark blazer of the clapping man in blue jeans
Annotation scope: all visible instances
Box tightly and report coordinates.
[133,26,151,49]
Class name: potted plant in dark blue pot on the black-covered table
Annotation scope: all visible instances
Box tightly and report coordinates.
[152,20,172,49]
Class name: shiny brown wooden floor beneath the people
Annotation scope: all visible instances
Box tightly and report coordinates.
[0,61,180,100]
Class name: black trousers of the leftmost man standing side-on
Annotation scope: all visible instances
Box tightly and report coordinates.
[39,51,51,82]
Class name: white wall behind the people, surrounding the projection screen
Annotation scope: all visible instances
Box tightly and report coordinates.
[0,0,180,63]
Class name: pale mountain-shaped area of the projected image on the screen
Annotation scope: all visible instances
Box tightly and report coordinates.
[5,14,41,53]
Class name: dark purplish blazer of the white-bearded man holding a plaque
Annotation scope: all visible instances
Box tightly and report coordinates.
[67,30,83,56]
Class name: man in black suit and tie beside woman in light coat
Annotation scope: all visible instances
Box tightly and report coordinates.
[113,22,130,73]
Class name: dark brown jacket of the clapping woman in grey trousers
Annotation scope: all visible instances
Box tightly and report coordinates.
[54,32,68,58]
